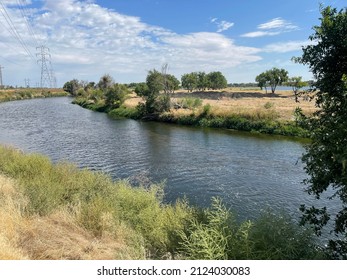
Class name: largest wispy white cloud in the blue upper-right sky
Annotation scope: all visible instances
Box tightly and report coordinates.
[241,17,299,38]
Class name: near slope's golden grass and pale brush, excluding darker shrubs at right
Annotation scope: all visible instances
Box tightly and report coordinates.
[0,146,191,259]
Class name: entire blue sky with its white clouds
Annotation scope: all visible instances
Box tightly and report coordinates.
[0,0,347,86]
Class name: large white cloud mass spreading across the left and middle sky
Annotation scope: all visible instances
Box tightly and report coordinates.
[0,0,261,86]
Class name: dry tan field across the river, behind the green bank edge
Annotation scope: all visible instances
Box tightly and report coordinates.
[125,88,316,120]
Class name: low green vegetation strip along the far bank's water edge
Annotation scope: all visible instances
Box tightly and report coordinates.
[73,98,309,138]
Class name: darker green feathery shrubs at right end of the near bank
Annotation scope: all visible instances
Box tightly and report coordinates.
[181,199,326,260]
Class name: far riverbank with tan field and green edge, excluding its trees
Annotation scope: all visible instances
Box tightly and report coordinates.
[74,88,315,138]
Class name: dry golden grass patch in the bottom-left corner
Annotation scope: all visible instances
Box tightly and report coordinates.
[0,174,131,260]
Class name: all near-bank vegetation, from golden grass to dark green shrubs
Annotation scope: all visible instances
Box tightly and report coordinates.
[0,146,327,259]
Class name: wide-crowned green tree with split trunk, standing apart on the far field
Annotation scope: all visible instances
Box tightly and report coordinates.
[255,67,288,93]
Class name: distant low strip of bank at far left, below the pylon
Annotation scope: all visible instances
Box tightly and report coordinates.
[0,88,68,102]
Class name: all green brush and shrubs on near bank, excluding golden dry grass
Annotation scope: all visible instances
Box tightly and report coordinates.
[0,146,326,259]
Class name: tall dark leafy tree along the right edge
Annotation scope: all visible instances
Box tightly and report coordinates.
[296,6,347,259]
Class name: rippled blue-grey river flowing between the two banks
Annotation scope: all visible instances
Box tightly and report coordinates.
[0,97,332,222]
